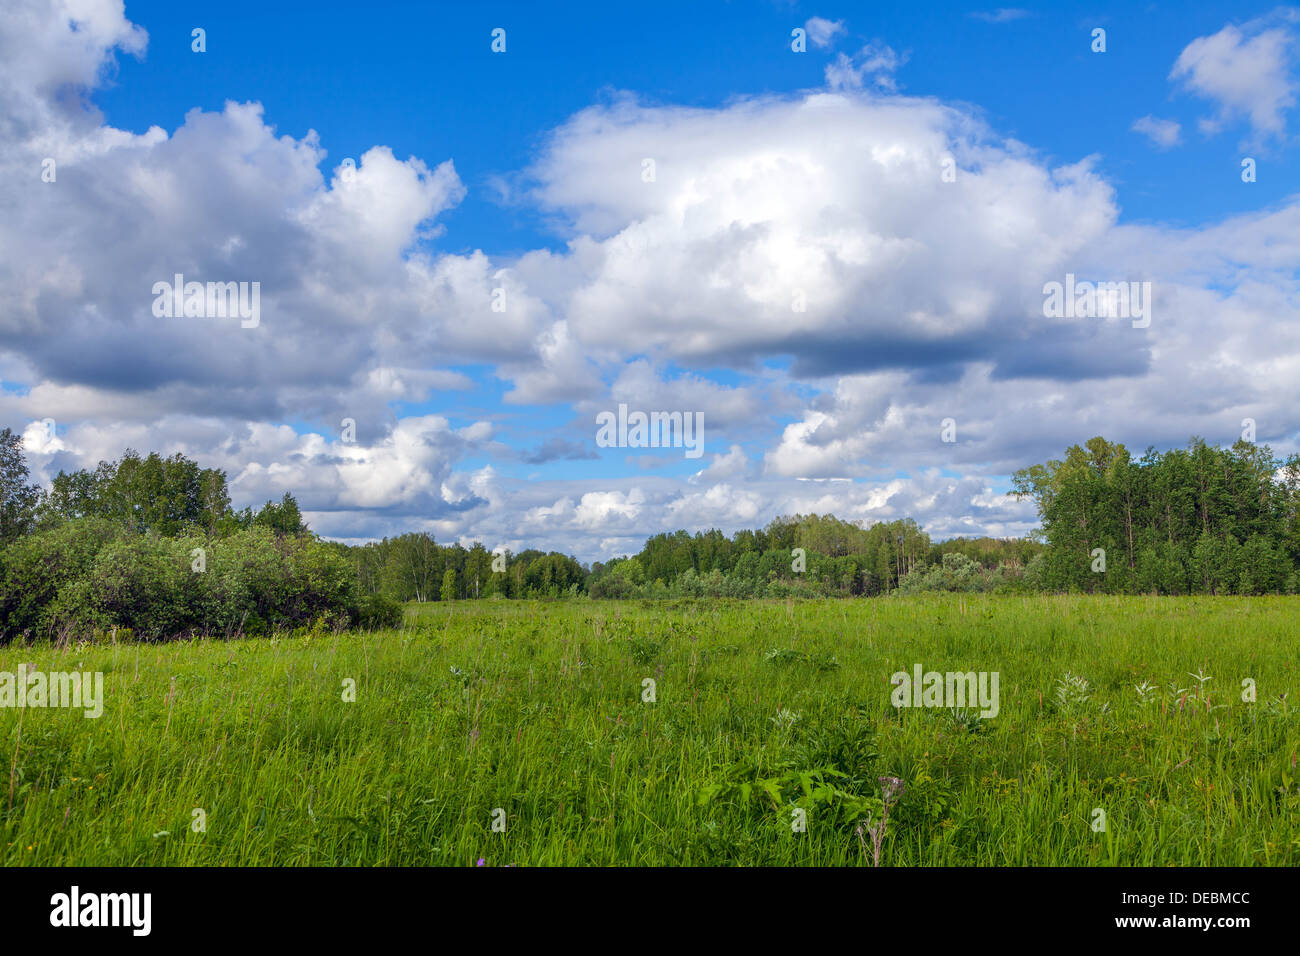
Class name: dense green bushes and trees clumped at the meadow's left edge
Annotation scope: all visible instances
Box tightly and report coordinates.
[0,428,402,643]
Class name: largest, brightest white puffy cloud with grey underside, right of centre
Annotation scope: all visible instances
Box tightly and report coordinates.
[533,94,1118,376]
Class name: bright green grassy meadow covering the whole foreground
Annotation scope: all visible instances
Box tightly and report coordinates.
[0,596,1300,866]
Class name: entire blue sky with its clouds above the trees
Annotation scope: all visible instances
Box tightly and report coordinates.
[0,0,1300,561]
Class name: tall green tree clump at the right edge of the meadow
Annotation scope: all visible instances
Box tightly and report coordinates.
[1011,437,1300,594]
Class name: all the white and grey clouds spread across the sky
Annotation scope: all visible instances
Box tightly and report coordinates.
[0,0,1300,559]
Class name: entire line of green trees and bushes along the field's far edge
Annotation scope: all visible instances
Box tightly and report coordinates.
[0,428,1300,640]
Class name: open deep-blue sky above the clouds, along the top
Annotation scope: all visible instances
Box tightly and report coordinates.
[95,0,1296,235]
